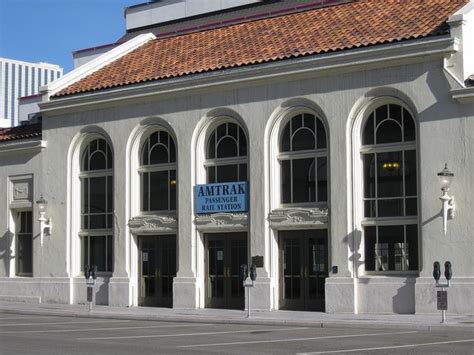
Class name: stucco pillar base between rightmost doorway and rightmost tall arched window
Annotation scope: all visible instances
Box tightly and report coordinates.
[325,277,354,313]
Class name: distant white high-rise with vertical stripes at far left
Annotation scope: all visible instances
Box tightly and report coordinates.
[0,58,63,127]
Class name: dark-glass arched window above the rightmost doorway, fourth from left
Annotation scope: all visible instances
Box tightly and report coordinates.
[278,113,328,204]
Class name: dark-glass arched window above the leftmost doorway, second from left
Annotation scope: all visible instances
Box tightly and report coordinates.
[139,131,176,212]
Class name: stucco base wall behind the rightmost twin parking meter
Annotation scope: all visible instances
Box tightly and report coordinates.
[415,277,474,314]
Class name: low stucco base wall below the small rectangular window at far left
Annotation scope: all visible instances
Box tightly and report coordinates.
[0,277,70,304]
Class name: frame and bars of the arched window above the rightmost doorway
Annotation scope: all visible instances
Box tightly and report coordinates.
[277,109,329,207]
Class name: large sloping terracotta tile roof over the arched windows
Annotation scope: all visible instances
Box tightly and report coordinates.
[54,0,468,97]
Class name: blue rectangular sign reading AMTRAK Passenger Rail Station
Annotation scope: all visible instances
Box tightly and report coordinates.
[194,181,248,213]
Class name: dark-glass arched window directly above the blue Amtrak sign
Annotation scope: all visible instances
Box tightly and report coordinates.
[204,122,247,184]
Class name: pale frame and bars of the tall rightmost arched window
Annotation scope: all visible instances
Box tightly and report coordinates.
[354,97,420,275]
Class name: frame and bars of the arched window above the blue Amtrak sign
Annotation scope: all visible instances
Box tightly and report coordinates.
[203,118,248,183]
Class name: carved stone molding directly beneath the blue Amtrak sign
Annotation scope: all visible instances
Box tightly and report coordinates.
[194,212,249,232]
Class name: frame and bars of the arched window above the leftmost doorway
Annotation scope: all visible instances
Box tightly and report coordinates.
[138,129,177,214]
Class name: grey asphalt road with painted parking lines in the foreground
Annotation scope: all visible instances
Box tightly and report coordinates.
[0,313,474,355]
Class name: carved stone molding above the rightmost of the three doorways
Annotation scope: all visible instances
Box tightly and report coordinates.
[268,207,328,229]
